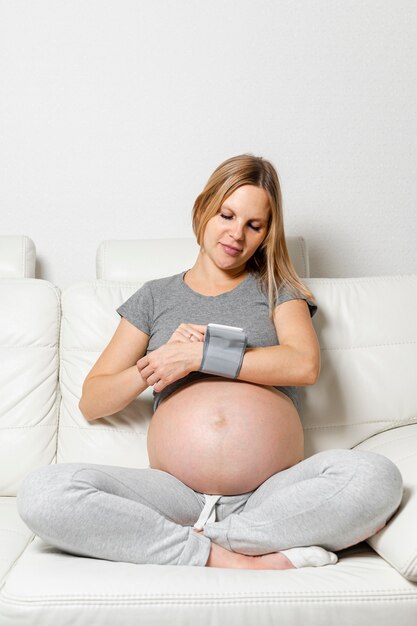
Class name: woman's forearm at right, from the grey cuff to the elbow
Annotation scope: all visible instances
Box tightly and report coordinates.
[238,346,320,387]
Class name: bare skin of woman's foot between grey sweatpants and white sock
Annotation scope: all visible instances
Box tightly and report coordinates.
[195,530,295,569]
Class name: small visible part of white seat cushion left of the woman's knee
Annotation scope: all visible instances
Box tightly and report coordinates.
[0,496,33,584]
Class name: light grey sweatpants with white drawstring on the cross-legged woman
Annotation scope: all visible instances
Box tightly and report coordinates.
[17,450,402,566]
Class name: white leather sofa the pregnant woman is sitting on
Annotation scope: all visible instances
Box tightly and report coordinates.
[0,237,417,626]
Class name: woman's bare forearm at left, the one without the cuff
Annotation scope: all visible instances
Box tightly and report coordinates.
[78,365,148,421]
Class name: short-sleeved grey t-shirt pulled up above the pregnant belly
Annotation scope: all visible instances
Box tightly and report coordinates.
[116,271,317,410]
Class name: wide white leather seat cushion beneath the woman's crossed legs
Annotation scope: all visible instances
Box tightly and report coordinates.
[0,537,417,626]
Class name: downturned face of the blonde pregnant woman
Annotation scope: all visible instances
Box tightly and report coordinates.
[203,185,270,269]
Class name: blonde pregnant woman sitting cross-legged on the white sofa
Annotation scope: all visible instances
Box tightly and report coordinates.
[18,154,402,569]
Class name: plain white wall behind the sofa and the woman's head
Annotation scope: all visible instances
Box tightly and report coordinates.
[0,0,417,288]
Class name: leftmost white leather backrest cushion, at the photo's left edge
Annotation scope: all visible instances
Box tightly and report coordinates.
[0,278,60,496]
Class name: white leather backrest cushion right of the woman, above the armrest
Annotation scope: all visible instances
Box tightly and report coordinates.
[300,274,417,456]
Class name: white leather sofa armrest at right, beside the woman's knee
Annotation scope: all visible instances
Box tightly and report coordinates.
[355,424,417,581]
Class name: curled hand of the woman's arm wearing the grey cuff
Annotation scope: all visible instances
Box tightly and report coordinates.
[137,341,203,393]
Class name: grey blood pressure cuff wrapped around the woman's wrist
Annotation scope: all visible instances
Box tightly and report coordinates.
[199,324,247,378]
